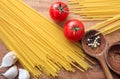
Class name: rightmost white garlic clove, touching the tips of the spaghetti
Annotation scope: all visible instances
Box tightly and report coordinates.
[18,69,30,79]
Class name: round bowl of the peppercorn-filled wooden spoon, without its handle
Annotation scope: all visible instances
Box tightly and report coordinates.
[82,30,107,57]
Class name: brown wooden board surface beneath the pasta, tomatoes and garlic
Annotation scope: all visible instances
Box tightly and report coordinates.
[0,0,120,79]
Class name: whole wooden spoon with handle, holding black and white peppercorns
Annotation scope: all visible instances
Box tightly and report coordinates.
[82,30,113,79]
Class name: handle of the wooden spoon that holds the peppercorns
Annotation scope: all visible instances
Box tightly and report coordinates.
[99,56,113,79]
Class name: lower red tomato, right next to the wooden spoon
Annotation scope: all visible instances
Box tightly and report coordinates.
[64,19,85,42]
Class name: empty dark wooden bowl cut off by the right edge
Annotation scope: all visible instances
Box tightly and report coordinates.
[106,42,120,75]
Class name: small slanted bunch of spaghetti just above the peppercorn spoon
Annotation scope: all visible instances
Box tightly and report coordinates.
[86,15,120,35]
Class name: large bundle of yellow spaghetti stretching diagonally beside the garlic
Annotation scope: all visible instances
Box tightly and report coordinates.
[0,0,92,77]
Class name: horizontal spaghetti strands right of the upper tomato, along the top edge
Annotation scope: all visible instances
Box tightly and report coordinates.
[68,0,120,20]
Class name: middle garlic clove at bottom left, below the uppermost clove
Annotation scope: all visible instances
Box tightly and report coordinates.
[1,66,18,79]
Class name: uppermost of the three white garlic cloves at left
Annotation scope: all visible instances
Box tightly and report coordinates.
[0,51,17,68]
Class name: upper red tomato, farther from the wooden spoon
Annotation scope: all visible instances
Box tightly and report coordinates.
[49,2,69,22]
